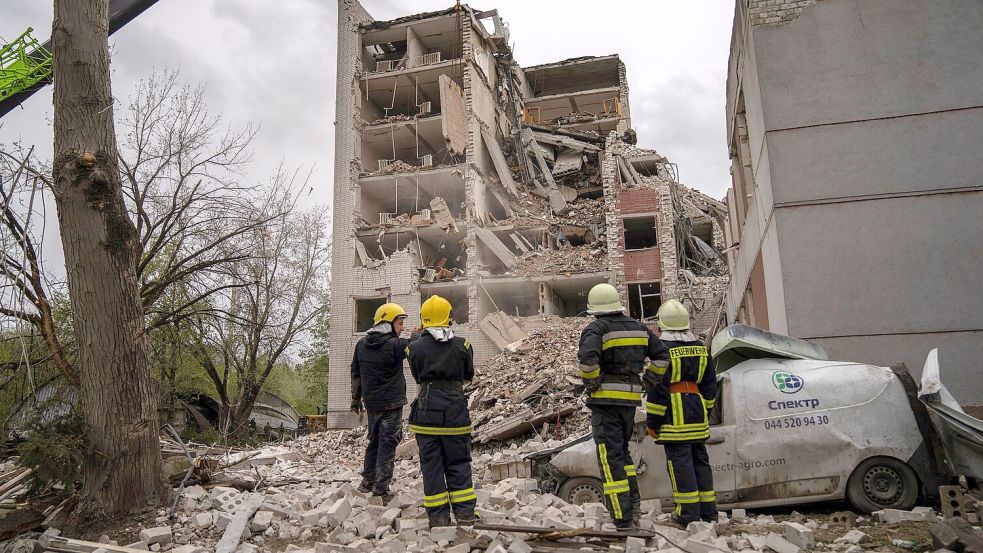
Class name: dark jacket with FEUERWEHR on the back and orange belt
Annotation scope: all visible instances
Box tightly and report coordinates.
[645,334,717,443]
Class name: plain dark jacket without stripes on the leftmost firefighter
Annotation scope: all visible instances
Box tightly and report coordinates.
[352,332,409,411]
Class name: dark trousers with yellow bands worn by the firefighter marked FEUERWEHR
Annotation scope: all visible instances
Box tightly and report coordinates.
[663,442,717,523]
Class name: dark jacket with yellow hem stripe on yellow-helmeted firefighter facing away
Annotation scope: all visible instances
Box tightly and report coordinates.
[406,332,474,436]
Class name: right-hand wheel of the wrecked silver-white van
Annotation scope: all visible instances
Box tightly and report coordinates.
[846,457,918,513]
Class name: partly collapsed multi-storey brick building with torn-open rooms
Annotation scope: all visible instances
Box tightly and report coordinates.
[328,0,728,427]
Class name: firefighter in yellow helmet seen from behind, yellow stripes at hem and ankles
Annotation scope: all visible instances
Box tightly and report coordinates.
[406,296,477,528]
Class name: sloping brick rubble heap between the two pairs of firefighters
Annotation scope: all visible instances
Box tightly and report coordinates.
[468,316,590,443]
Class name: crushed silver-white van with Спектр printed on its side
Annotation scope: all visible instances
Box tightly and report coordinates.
[528,325,939,512]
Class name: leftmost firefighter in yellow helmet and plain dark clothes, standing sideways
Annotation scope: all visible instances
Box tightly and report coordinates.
[351,303,409,501]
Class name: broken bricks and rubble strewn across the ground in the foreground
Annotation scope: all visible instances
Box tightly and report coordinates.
[0,426,983,553]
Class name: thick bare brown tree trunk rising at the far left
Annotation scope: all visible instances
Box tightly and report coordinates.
[51,0,167,520]
